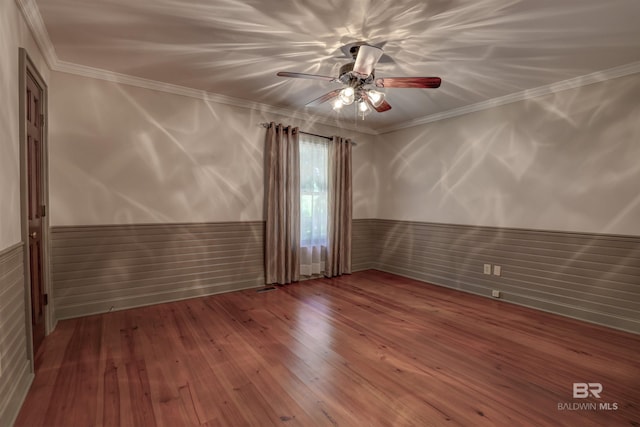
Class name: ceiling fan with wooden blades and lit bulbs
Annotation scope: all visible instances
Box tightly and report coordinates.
[277,43,442,118]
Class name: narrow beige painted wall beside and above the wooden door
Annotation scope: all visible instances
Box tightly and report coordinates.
[0,0,49,250]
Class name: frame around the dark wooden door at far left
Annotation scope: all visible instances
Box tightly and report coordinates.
[19,48,55,371]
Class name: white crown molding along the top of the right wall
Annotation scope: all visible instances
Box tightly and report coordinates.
[378,61,640,134]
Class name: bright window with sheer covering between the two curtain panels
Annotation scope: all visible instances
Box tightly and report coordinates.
[300,134,329,276]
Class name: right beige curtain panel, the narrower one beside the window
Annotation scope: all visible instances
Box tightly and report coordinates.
[325,136,353,277]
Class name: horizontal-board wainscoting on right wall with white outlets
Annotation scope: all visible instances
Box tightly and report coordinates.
[370,220,640,333]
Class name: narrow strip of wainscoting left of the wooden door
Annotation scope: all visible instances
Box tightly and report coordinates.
[0,243,33,426]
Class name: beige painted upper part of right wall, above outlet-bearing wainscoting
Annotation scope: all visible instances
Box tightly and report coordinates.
[374,74,640,235]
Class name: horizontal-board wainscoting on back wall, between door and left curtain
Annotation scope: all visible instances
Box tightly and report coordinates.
[51,221,264,319]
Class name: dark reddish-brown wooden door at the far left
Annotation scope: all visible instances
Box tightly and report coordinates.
[24,72,45,355]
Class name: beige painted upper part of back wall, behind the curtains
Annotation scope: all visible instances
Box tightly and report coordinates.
[50,72,375,226]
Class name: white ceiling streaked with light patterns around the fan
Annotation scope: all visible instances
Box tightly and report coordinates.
[36,0,640,131]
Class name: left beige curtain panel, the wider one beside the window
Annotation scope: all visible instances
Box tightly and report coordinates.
[264,122,300,284]
